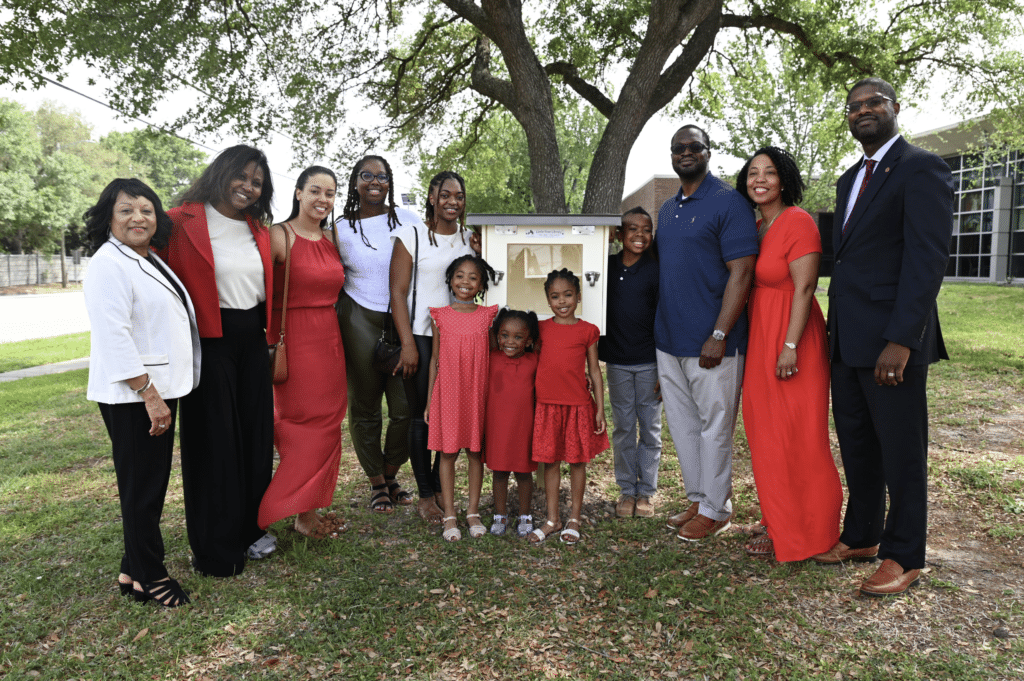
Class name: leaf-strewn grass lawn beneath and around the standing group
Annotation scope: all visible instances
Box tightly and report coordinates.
[0,285,1024,681]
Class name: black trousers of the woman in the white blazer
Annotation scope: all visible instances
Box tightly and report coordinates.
[99,399,178,584]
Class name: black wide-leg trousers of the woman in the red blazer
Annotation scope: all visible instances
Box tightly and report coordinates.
[181,305,273,577]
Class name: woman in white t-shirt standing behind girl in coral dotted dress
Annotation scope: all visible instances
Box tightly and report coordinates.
[390,170,480,522]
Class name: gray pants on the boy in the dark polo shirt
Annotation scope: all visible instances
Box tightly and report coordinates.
[605,364,662,498]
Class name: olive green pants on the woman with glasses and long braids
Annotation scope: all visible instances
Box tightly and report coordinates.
[338,295,409,477]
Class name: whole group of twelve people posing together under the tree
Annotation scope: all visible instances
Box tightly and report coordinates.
[85,79,952,607]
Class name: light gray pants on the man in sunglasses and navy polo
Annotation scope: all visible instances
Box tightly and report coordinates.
[657,350,744,520]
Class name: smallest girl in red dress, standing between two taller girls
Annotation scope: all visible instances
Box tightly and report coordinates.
[483,307,541,537]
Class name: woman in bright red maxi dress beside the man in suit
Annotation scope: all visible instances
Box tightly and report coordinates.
[736,146,843,561]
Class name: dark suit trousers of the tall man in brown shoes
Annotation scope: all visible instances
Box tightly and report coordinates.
[831,361,928,569]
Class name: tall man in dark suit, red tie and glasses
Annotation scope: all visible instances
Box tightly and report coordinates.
[814,78,953,596]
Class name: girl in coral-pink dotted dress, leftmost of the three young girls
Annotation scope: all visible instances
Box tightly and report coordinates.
[423,255,498,542]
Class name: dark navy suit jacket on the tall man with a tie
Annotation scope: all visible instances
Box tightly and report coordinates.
[828,137,953,368]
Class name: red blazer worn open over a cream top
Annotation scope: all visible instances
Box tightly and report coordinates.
[157,203,273,338]
